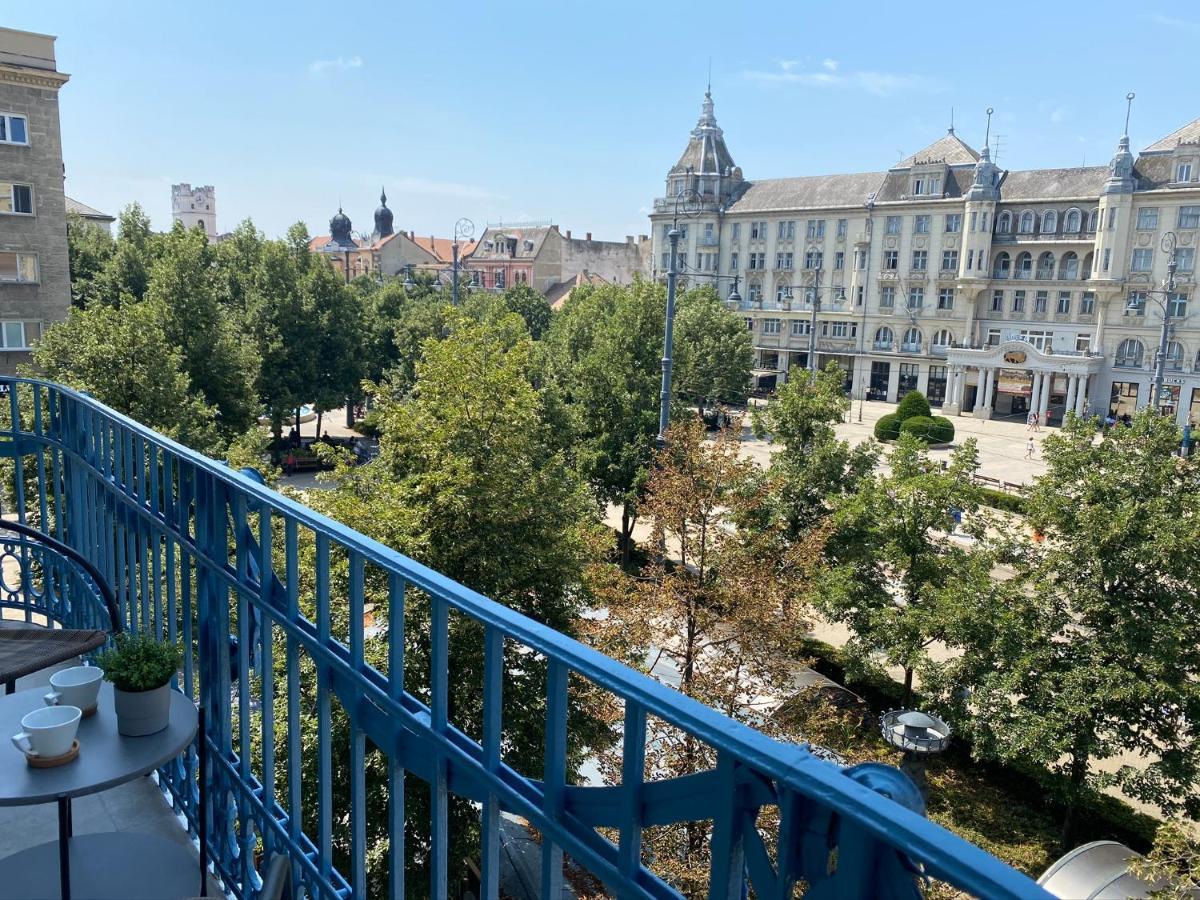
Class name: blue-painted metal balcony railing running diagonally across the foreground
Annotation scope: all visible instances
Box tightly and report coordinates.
[0,378,1049,900]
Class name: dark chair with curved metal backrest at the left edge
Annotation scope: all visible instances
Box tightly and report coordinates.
[0,520,121,694]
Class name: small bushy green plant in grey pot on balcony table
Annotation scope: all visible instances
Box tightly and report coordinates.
[97,634,180,737]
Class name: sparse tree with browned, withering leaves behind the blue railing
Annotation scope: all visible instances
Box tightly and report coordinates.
[596,416,821,896]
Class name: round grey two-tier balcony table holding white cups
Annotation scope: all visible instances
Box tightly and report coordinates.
[0,682,200,900]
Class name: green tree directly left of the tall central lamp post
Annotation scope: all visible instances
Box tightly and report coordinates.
[545,280,666,563]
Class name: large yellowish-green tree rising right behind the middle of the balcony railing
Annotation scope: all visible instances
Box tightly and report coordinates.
[291,310,610,896]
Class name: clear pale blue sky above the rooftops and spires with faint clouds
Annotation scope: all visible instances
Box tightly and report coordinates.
[14,0,1200,239]
